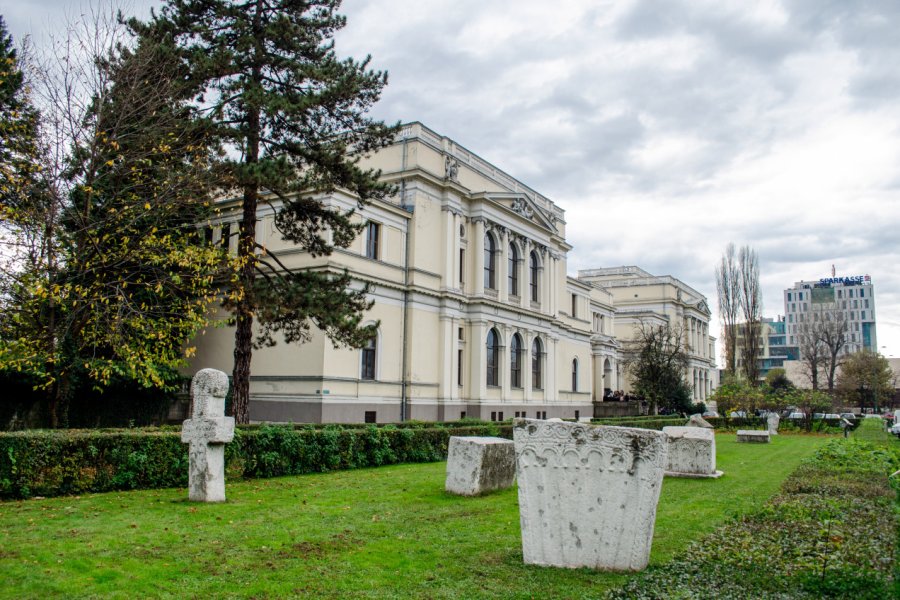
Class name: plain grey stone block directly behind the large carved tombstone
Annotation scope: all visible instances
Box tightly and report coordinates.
[444,436,516,496]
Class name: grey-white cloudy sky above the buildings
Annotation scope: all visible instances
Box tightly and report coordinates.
[7,0,900,364]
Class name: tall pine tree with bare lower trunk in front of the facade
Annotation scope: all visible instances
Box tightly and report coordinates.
[131,0,395,422]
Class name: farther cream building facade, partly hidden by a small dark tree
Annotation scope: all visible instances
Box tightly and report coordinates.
[578,266,718,401]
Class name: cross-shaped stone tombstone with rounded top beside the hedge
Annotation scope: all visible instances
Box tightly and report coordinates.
[181,369,234,502]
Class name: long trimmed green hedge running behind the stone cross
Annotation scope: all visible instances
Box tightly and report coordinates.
[0,425,512,498]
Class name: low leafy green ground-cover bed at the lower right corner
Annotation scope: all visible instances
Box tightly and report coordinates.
[607,439,900,600]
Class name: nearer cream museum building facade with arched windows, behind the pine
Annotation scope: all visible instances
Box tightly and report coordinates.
[185,123,618,422]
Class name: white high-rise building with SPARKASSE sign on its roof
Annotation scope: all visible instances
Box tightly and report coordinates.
[784,275,878,356]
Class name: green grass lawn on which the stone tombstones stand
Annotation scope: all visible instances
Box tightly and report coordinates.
[0,433,827,598]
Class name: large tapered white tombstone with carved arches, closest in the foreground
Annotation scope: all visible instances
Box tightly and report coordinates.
[513,419,667,571]
